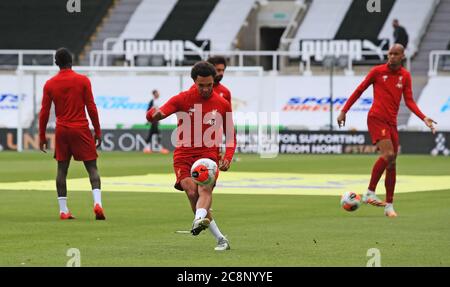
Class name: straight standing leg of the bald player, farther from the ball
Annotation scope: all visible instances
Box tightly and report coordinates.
[384,128,399,217]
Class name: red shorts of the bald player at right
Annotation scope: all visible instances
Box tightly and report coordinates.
[367,116,399,153]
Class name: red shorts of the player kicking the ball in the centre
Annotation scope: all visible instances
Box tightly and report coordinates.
[173,153,219,191]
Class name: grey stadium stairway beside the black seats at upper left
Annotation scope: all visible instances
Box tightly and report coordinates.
[80,0,142,66]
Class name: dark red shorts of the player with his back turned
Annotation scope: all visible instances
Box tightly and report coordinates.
[54,126,98,161]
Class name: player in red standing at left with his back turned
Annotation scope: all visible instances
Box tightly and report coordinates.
[39,48,105,220]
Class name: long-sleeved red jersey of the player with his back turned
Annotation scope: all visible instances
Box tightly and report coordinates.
[39,69,101,141]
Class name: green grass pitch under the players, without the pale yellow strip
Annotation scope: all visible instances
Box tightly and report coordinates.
[0,152,450,267]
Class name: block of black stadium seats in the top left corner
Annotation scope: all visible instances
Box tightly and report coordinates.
[0,0,113,58]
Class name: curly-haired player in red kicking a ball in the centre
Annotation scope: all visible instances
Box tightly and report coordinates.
[147,61,236,251]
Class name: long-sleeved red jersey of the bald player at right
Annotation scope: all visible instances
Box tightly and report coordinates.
[342,64,425,125]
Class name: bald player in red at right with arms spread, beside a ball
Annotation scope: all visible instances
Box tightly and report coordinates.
[337,44,436,217]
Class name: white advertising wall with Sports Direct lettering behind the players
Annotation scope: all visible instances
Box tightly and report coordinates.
[0,74,450,131]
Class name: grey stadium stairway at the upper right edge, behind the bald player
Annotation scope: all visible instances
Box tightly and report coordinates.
[398,0,450,126]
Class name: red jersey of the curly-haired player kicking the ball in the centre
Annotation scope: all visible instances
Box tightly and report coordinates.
[160,85,236,161]
